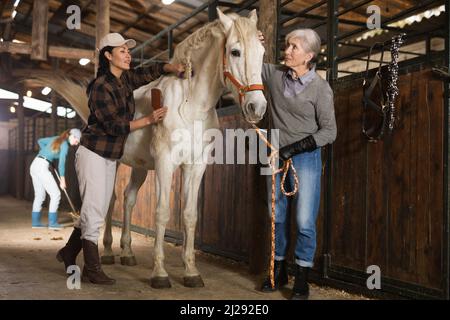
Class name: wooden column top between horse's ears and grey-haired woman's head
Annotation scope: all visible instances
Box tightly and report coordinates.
[258,0,280,63]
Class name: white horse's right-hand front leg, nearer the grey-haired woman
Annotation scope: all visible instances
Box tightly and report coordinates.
[182,164,206,288]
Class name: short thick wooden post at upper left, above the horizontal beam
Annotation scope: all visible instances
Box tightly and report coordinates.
[31,0,48,60]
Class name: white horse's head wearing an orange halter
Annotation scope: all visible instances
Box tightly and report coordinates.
[217,10,267,123]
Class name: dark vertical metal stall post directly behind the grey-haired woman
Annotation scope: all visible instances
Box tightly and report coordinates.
[322,0,339,278]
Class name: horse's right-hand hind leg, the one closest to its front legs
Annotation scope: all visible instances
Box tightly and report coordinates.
[120,168,147,266]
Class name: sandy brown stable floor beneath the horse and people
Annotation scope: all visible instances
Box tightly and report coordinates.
[0,197,364,300]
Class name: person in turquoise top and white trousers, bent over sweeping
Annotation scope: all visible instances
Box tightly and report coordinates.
[30,128,81,230]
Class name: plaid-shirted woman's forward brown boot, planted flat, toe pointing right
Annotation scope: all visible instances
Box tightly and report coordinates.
[81,239,116,284]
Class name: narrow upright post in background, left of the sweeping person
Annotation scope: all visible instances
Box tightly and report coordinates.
[16,88,25,199]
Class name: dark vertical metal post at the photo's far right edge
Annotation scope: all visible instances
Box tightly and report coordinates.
[442,1,450,300]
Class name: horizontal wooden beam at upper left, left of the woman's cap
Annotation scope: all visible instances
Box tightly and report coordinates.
[0,41,94,60]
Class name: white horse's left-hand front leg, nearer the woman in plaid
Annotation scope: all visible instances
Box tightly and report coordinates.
[151,157,175,289]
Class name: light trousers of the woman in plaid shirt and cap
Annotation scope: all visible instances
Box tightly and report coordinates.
[75,146,117,243]
